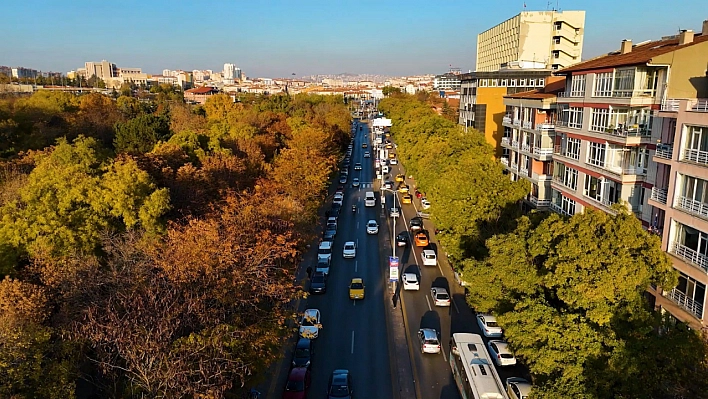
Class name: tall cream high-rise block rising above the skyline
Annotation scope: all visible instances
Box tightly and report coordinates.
[476,11,585,72]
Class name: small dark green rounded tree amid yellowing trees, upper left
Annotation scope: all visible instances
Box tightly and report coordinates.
[113,114,171,154]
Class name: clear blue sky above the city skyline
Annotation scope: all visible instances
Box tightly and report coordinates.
[0,0,708,77]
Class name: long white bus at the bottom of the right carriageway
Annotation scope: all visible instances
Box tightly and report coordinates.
[449,333,509,399]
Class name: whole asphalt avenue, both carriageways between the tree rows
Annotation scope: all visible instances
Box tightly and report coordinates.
[267,119,523,399]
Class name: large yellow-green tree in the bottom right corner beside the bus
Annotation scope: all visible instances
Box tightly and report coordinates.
[464,208,706,398]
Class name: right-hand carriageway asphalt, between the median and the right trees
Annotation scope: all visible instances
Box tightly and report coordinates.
[386,132,525,399]
